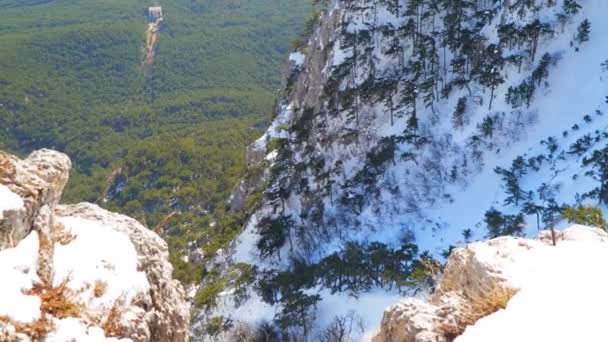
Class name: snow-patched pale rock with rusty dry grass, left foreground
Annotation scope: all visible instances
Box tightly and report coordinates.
[0,150,189,342]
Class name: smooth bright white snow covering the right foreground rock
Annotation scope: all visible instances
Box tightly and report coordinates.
[456,229,608,342]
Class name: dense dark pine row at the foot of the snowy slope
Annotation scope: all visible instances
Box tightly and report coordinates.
[256,242,440,338]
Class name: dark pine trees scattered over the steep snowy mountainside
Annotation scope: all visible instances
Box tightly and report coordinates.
[208,0,599,336]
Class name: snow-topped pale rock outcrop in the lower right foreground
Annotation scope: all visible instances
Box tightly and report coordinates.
[374,225,608,342]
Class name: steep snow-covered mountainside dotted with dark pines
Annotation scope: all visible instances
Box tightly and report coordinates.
[193,0,608,340]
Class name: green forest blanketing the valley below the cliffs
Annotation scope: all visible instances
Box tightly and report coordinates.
[0,0,312,282]
